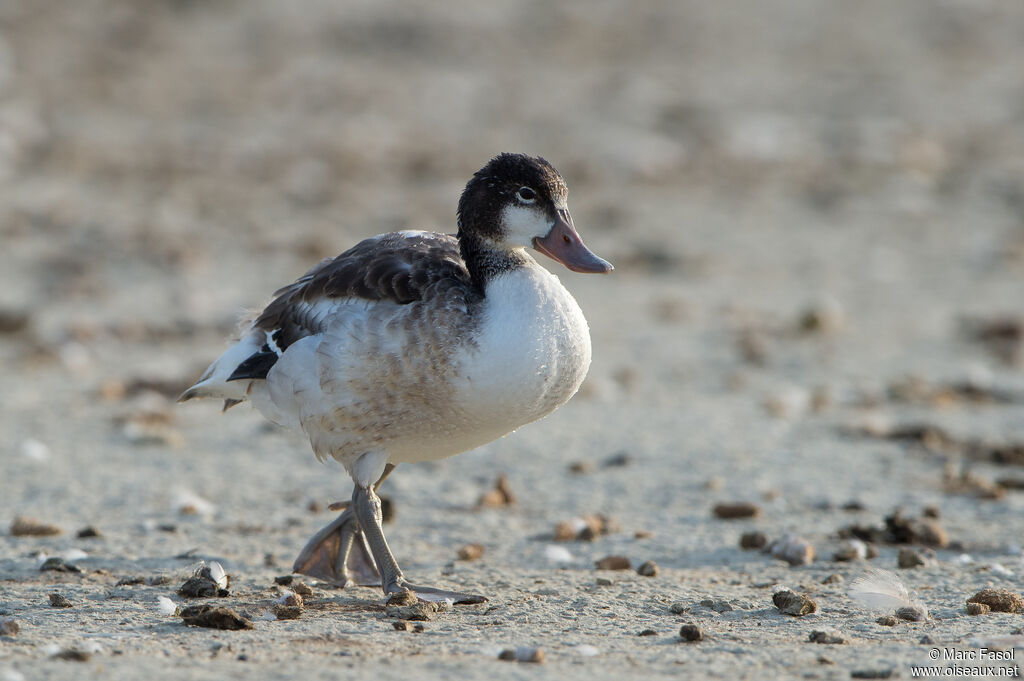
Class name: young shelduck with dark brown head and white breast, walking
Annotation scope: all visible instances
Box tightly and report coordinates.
[180,154,612,603]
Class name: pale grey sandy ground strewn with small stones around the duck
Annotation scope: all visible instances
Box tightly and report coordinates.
[0,0,1024,681]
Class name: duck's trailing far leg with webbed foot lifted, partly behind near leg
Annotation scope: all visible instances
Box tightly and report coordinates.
[292,464,394,587]
